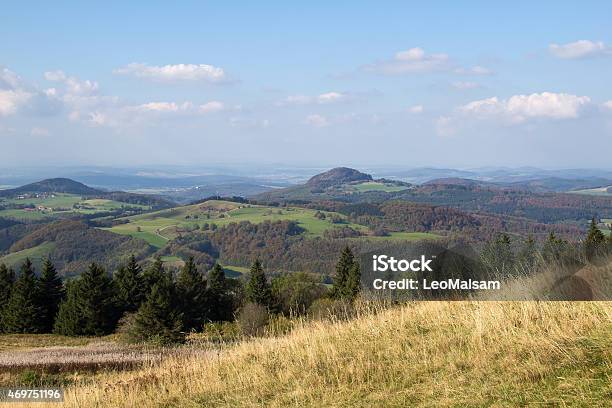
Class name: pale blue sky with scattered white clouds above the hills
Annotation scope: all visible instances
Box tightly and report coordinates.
[0,1,612,169]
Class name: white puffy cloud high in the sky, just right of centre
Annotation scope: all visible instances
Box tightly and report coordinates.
[365,47,451,75]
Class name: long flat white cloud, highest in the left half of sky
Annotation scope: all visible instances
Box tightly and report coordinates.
[113,63,227,83]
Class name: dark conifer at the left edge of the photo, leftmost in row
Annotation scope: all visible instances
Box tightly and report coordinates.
[2,258,40,333]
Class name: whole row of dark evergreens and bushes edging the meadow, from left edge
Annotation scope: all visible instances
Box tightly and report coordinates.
[0,247,360,344]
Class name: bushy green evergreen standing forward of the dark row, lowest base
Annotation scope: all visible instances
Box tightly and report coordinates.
[128,270,185,345]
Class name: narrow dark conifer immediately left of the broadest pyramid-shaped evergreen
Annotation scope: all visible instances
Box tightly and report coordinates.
[38,259,65,333]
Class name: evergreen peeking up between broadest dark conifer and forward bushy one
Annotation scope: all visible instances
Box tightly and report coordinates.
[113,255,145,314]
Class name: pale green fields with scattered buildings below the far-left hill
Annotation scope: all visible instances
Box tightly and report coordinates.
[0,193,149,220]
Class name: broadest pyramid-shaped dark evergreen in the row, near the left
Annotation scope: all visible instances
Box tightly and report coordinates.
[54,263,118,336]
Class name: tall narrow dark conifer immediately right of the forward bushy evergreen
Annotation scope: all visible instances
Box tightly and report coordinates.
[176,257,206,331]
